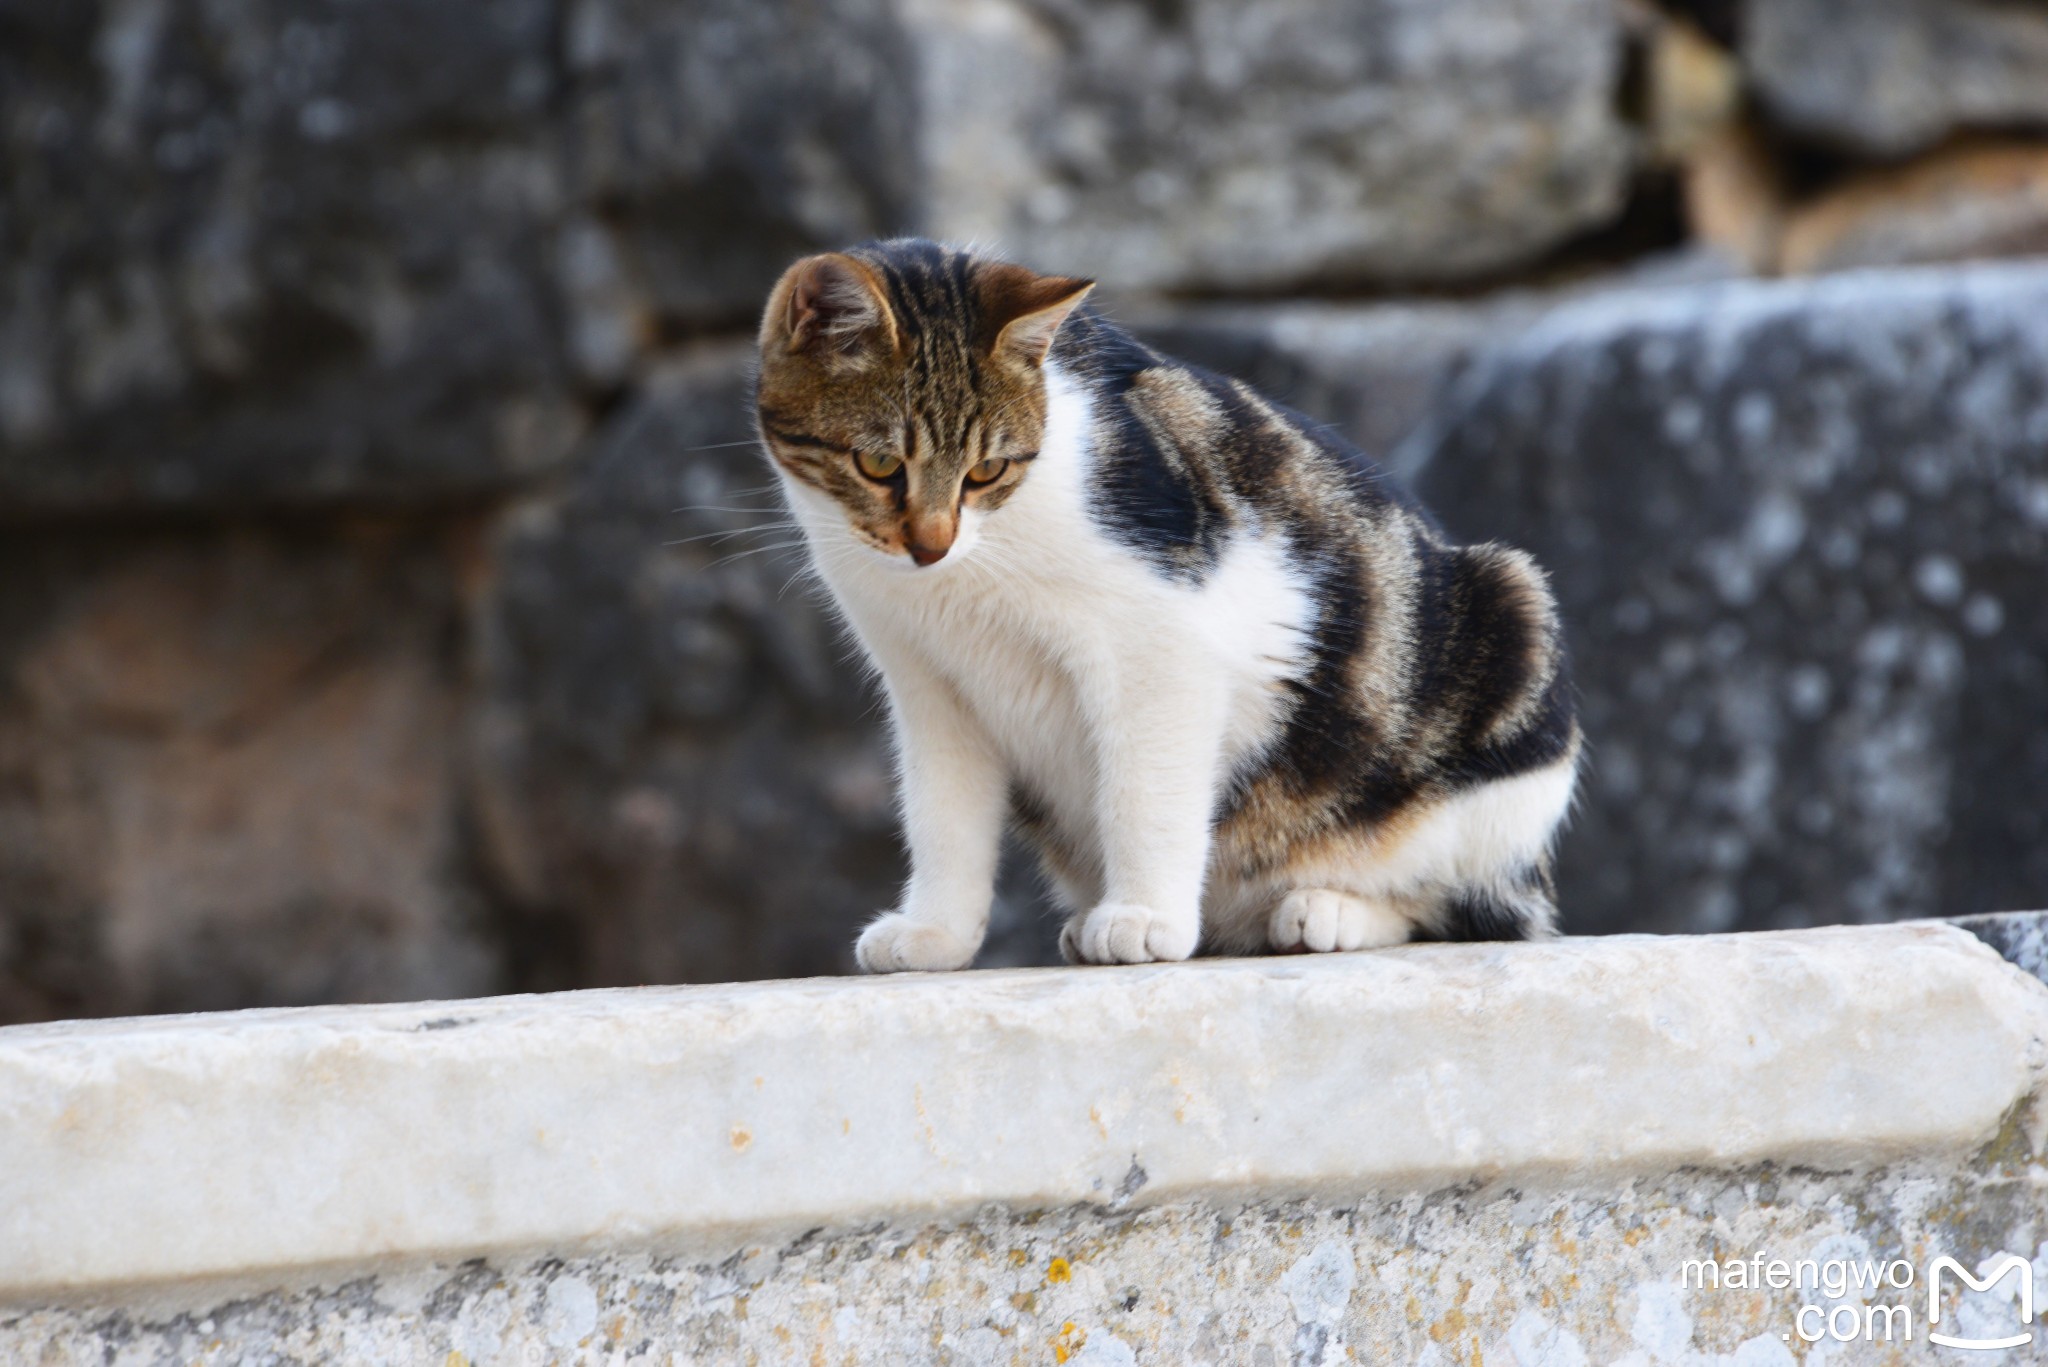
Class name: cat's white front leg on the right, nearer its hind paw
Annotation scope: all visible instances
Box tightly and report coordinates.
[1059,644,1225,963]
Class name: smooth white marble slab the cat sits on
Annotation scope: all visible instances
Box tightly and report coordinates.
[0,924,2048,1301]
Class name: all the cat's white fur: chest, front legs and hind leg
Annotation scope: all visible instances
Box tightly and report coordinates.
[784,365,1571,971]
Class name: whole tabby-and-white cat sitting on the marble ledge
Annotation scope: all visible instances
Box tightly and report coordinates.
[756,240,1581,971]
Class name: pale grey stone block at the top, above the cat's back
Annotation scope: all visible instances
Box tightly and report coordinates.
[905,0,1632,289]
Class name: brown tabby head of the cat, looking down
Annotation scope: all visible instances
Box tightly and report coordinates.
[758,240,1092,566]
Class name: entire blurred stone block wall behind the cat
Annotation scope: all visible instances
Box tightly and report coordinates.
[0,0,2048,1021]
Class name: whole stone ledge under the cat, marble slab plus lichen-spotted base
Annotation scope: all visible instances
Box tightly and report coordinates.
[0,926,2048,1367]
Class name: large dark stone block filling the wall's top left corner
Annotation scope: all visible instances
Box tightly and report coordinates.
[0,0,584,514]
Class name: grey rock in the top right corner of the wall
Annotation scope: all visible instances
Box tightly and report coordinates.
[1741,0,2048,156]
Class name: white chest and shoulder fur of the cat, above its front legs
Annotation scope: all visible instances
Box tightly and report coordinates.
[782,362,1315,860]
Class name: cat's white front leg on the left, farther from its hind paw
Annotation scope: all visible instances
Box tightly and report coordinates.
[854,652,1008,974]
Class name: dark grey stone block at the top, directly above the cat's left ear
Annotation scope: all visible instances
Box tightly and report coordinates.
[565,0,930,324]
